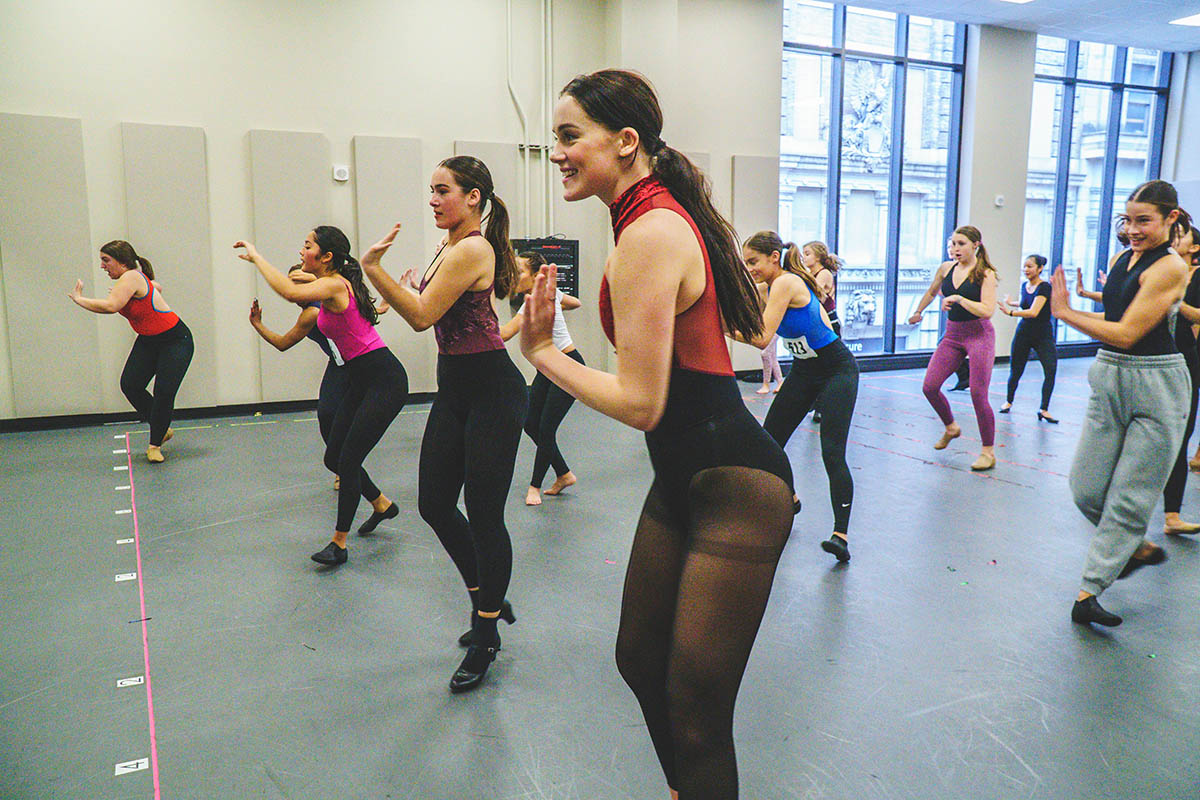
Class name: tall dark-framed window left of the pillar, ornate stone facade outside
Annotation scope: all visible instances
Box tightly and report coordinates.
[779,0,964,354]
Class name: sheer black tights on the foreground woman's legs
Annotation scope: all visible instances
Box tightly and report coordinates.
[617,467,792,800]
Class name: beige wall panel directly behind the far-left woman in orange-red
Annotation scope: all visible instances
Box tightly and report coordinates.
[121,122,218,408]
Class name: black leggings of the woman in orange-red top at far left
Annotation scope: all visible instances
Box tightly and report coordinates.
[121,320,196,447]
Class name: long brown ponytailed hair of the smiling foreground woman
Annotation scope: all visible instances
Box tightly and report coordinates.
[559,70,762,338]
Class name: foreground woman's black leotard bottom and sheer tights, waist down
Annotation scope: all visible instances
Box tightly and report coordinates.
[617,369,792,800]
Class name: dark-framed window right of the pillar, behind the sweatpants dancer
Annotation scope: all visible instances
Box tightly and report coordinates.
[1025,36,1171,342]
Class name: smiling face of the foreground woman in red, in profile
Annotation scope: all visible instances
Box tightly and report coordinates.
[550,95,641,203]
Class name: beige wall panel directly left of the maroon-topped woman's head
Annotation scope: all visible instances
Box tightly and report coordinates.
[354,136,438,392]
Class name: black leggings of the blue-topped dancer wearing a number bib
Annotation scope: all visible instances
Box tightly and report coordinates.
[762,339,858,534]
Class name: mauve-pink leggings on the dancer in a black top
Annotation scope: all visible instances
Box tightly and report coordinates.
[920,319,996,447]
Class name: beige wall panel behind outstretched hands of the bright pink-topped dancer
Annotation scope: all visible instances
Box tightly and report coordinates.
[248,131,331,401]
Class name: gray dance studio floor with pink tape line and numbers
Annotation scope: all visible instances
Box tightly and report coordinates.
[0,359,1200,800]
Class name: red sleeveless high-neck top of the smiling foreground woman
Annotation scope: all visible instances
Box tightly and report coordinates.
[598,175,733,375]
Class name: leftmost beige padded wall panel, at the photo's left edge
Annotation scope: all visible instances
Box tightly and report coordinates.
[0,114,101,416]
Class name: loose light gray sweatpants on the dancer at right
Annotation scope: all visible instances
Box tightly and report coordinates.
[1070,350,1192,595]
